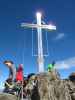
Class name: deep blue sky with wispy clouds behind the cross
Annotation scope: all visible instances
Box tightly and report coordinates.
[0,0,75,87]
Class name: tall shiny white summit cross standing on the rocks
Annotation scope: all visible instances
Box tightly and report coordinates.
[21,12,56,72]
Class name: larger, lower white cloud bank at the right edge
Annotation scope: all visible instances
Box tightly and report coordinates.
[55,57,75,69]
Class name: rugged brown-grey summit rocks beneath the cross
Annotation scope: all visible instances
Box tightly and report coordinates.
[0,70,75,100]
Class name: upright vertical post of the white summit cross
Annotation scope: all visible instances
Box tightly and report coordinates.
[36,13,44,72]
